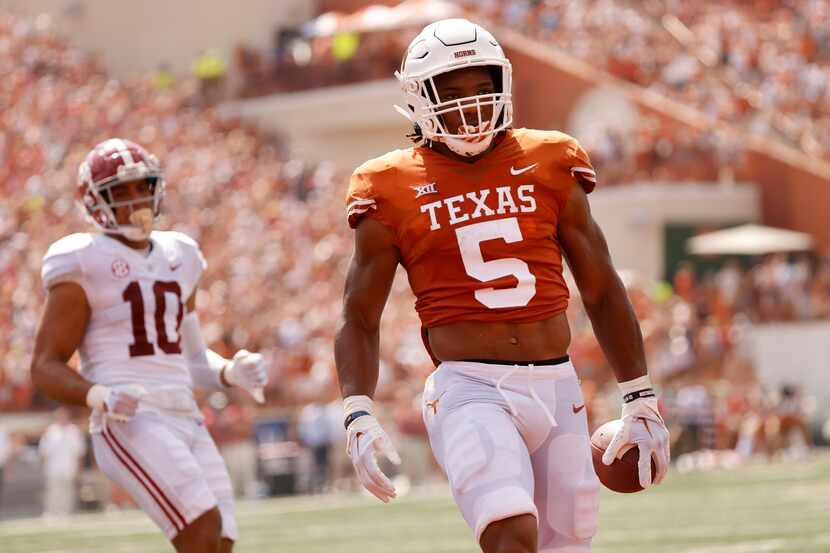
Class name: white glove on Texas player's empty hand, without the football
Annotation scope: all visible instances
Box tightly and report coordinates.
[343,396,401,503]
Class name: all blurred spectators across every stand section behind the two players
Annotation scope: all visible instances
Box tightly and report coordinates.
[0,0,830,512]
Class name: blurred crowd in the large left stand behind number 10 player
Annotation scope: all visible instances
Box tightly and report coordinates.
[0,8,425,416]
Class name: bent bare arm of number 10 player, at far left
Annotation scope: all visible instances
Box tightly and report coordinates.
[31,282,92,405]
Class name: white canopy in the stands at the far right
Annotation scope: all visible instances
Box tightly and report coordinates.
[686,224,813,255]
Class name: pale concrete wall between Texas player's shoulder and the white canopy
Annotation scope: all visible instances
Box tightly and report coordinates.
[589,183,761,280]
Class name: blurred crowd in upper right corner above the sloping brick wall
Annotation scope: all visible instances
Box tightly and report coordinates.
[461,0,830,159]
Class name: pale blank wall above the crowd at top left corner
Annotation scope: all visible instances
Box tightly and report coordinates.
[0,0,316,77]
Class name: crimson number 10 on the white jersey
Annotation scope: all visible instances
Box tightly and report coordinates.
[122,281,184,357]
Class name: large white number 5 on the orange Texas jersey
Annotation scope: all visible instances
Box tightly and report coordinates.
[455,217,536,309]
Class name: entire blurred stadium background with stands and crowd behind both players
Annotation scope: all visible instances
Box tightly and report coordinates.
[0,0,830,517]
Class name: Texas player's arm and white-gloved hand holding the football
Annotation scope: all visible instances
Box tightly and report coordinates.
[559,187,669,488]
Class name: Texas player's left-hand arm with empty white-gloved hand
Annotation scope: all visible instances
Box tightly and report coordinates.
[334,218,400,503]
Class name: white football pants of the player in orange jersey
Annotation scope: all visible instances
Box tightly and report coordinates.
[423,360,599,553]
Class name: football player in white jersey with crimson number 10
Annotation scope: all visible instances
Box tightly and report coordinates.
[32,139,267,553]
